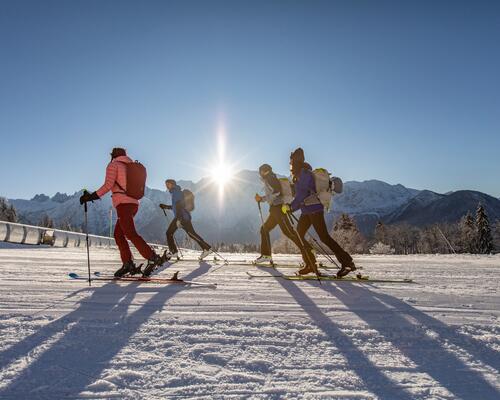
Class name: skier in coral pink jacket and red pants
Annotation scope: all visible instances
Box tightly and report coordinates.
[80,147,164,277]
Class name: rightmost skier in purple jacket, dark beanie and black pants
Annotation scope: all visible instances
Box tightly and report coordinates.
[282,147,356,278]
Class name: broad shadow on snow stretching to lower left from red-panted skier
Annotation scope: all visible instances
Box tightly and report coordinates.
[0,263,210,399]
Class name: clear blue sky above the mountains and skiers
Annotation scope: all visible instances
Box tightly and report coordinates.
[0,0,500,197]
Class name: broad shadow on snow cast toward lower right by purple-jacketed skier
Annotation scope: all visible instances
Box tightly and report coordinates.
[311,282,500,400]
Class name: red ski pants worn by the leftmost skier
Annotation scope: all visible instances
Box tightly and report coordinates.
[115,204,154,263]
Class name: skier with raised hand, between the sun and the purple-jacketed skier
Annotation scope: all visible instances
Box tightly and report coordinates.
[255,164,316,273]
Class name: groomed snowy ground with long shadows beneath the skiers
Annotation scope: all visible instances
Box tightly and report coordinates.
[0,245,500,400]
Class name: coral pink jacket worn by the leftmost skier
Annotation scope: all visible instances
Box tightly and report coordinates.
[97,156,139,208]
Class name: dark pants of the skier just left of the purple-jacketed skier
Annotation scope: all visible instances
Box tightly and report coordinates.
[260,206,316,265]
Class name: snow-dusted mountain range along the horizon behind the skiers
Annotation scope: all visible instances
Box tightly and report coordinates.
[4,170,500,243]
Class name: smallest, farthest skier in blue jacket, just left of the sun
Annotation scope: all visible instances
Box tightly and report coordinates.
[160,179,213,261]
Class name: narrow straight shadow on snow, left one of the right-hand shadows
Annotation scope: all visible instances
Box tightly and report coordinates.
[270,270,412,400]
